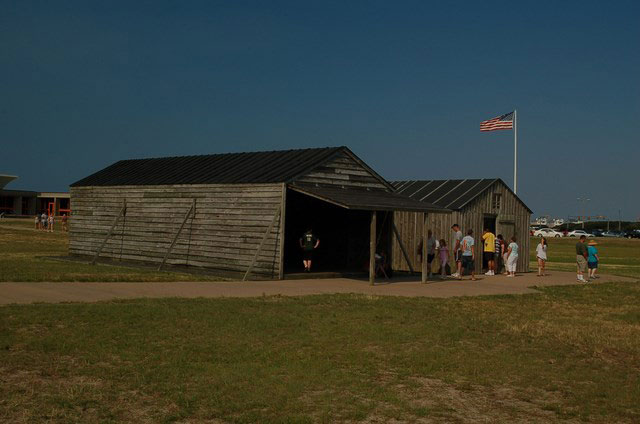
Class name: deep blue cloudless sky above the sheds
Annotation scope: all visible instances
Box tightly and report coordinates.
[0,1,640,219]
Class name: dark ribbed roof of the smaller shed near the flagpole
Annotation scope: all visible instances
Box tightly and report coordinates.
[391,178,531,212]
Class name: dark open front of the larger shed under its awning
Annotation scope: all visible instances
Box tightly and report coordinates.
[284,190,392,274]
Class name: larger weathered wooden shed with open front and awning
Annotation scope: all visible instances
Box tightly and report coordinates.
[69,147,442,279]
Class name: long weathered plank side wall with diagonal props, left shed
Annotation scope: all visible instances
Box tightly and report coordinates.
[69,183,284,278]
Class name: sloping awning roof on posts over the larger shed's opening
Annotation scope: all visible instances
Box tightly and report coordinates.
[289,185,451,212]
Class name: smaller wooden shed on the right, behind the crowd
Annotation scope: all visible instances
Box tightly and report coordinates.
[392,178,532,272]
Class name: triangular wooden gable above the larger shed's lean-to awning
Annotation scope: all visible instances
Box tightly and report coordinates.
[295,152,389,190]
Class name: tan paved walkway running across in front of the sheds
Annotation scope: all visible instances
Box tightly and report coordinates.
[0,271,635,305]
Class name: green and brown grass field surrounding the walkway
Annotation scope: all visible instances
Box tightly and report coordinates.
[0,222,640,423]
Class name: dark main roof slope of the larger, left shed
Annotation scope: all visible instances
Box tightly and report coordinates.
[71,147,348,187]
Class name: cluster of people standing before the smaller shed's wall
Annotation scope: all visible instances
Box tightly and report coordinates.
[418,224,519,281]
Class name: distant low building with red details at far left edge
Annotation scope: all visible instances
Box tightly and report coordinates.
[0,174,71,215]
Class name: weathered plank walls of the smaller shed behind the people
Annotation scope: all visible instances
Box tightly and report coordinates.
[391,182,531,272]
